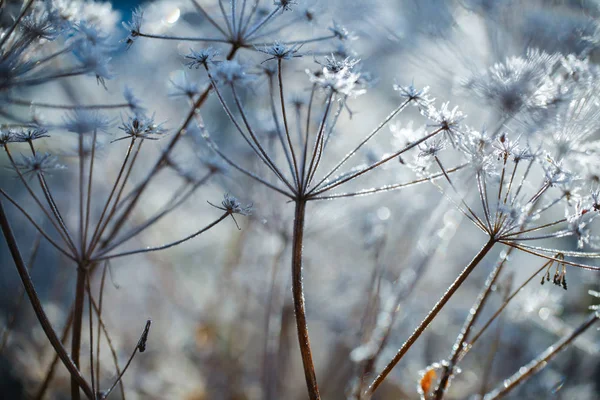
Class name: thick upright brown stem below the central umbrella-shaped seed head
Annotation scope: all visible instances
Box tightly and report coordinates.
[292,199,321,400]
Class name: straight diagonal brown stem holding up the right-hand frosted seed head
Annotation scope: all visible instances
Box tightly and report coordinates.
[367,238,496,397]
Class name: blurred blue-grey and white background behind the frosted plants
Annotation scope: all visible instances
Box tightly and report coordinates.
[0,0,600,400]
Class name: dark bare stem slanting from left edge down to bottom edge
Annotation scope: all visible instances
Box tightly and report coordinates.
[0,202,94,399]
